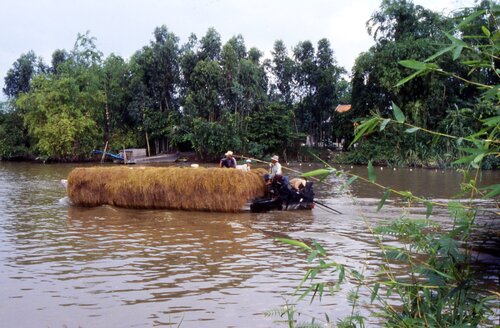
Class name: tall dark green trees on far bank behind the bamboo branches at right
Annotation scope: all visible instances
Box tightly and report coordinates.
[349,0,485,165]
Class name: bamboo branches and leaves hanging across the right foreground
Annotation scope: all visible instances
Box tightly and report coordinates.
[276,1,500,327]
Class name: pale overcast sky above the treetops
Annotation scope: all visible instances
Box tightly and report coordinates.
[0,0,473,99]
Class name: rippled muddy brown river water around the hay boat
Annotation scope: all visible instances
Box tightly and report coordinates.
[0,162,500,327]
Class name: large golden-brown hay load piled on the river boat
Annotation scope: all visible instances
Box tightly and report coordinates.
[68,167,266,212]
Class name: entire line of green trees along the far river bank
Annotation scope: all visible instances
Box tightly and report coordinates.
[0,0,500,169]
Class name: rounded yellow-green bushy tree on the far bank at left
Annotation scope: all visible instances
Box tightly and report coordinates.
[16,77,104,159]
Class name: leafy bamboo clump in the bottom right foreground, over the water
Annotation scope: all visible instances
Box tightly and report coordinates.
[375,211,490,327]
